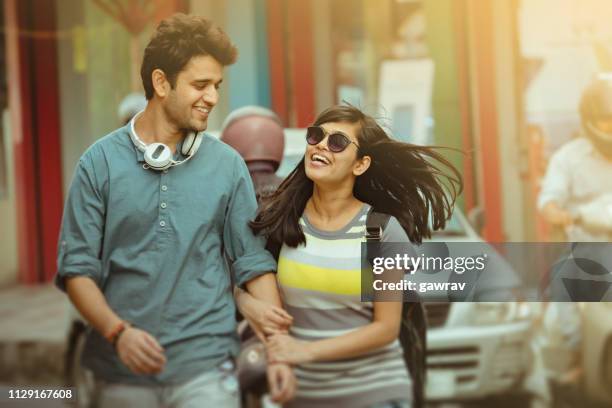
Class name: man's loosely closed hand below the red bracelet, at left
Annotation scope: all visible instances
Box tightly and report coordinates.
[117,327,166,375]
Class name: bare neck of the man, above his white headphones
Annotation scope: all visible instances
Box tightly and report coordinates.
[134,101,185,153]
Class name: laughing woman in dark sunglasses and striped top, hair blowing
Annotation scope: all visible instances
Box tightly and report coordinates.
[238,106,462,408]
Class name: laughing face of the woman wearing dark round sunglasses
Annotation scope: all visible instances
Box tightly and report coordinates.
[304,122,370,185]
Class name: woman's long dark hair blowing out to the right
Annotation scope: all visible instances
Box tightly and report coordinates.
[250,105,463,252]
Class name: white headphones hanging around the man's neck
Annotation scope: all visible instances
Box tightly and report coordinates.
[130,111,203,171]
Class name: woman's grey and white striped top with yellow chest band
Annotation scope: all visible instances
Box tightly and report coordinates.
[278,205,411,408]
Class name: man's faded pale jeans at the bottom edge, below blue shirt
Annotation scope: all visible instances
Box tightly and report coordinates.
[94,363,240,408]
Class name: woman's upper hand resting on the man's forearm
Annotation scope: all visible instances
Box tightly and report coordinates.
[236,289,293,342]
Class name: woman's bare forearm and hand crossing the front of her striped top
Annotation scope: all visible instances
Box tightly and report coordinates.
[268,302,402,364]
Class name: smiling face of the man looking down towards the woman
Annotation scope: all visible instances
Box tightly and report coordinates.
[162,55,223,132]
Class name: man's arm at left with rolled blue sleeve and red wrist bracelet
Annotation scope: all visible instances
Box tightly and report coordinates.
[56,155,165,374]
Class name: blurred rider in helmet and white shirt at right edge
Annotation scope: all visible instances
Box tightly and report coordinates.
[538,74,612,401]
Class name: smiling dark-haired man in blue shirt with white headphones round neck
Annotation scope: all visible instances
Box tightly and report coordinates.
[56,14,294,407]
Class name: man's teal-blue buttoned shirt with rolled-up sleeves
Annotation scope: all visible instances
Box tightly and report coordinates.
[56,126,276,384]
